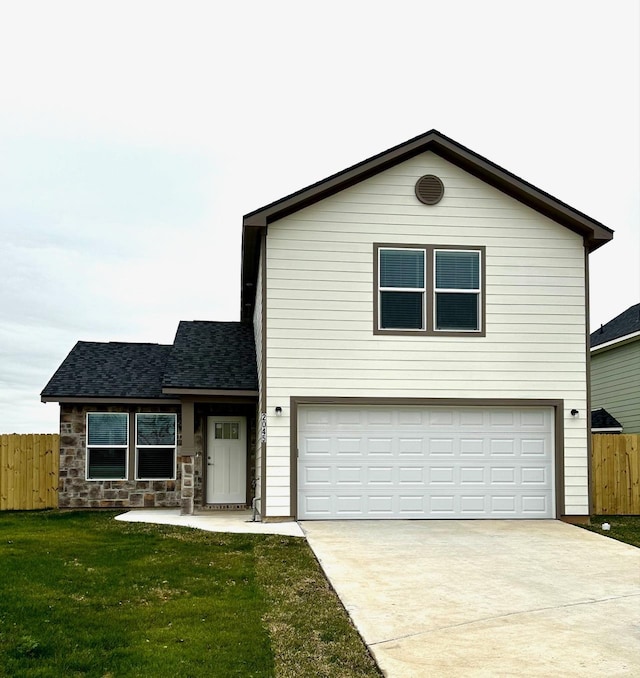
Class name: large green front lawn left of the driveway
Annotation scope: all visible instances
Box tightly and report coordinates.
[0,511,380,678]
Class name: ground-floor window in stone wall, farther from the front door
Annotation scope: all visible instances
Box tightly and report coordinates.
[87,412,129,480]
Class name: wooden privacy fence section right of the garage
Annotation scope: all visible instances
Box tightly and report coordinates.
[591,433,640,516]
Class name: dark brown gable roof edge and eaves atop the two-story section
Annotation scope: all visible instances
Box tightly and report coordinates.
[241,130,613,319]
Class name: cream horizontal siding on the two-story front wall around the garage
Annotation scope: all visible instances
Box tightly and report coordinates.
[266,152,588,516]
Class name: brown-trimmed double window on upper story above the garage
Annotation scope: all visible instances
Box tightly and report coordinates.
[374,245,485,336]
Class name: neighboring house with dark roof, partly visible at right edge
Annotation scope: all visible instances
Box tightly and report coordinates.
[591,304,640,433]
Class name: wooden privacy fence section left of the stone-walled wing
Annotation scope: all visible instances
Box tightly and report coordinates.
[0,433,60,511]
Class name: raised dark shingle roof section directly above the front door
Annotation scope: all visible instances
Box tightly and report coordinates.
[163,320,258,391]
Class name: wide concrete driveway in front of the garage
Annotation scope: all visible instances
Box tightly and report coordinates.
[302,520,640,678]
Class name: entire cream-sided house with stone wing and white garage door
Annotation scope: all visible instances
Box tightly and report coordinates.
[43,131,612,520]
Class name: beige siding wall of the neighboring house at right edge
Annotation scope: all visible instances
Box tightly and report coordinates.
[591,337,640,433]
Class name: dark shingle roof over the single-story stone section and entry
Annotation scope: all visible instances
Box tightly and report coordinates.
[41,321,258,402]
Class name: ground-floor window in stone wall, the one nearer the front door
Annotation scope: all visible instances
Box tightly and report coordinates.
[136,413,176,480]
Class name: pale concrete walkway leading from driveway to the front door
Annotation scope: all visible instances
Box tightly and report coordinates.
[116,509,304,537]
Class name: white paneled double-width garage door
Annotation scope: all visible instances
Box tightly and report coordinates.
[298,406,554,520]
